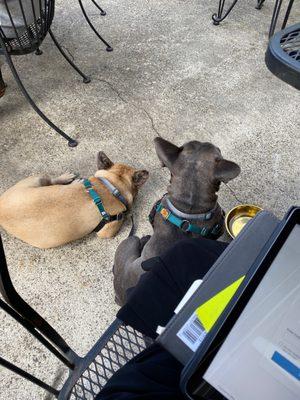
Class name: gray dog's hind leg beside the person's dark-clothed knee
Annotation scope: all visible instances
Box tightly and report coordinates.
[113,236,144,305]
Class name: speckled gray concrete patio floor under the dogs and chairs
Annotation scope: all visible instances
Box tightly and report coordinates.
[0,0,300,400]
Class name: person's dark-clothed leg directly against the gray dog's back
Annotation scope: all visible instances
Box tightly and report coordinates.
[117,239,227,338]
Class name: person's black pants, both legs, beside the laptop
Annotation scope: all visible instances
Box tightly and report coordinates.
[97,239,227,400]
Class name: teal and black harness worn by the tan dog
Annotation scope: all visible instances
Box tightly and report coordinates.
[83,178,129,232]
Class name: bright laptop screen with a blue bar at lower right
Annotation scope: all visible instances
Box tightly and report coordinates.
[203,225,300,400]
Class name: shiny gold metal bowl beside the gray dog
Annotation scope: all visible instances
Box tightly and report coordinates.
[225,204,262,239]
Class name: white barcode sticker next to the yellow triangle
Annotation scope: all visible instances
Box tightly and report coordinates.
[177,313,207,352]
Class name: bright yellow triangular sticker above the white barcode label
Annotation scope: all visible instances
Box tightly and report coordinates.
[196,276,245,332]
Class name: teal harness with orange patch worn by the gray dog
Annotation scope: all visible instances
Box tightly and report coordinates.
[149,197,224,239]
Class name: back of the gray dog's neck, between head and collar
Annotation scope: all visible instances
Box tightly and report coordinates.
[168,179,220,214]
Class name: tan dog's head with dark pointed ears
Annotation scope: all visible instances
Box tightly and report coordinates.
[97,151,149,195]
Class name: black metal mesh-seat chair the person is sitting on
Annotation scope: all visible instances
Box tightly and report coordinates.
[0,237,151,400]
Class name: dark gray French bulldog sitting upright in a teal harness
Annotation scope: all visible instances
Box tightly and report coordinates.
[114,137,240,305]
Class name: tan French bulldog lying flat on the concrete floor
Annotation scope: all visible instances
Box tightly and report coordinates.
[0,152,149,249]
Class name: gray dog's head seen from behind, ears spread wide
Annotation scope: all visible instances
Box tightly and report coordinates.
[155,138,240,196]
